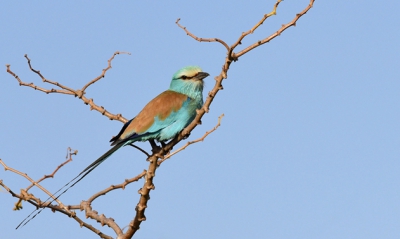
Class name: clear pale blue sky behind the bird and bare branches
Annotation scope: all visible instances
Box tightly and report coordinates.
[0,0,400,239]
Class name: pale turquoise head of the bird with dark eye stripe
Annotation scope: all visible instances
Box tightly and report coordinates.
[169,66,209,97]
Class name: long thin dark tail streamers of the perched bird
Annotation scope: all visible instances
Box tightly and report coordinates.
[15,143,124,229]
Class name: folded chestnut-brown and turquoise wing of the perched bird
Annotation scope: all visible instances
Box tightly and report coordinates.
[110,90,191,145]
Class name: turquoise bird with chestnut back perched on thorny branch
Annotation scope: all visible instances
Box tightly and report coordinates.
[16,66,209,229]
